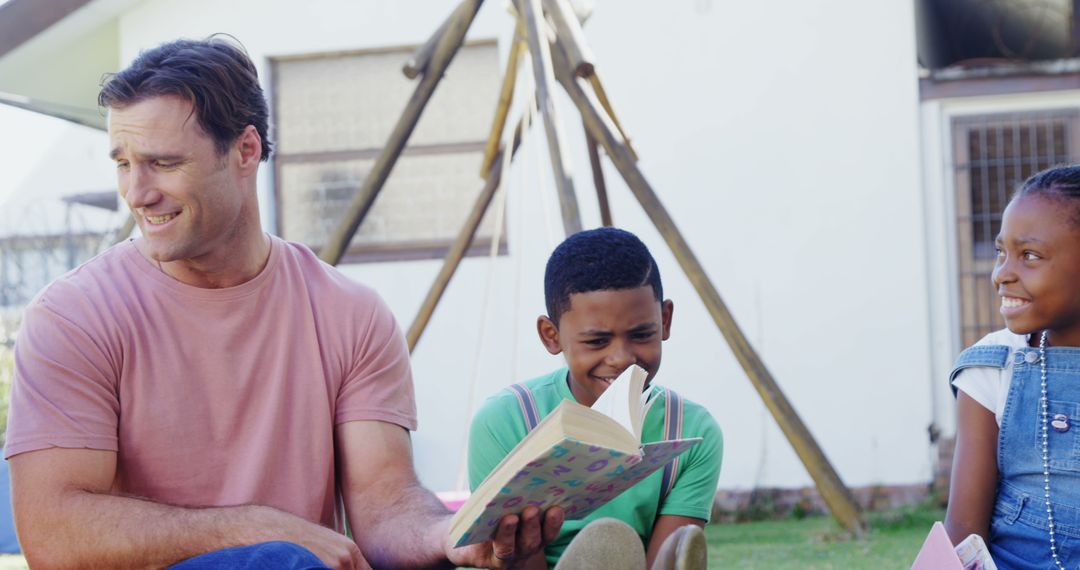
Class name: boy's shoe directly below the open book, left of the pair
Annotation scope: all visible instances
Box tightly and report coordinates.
[555,518,645,570]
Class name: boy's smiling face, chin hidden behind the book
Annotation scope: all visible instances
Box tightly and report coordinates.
[537,285,673,406]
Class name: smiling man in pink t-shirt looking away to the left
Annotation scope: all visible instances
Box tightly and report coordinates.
[4,38,563,568]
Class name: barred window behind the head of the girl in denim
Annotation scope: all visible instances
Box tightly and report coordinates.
[953,110,1080,347]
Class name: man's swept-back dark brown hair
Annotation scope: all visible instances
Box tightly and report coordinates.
[97,36,273,160]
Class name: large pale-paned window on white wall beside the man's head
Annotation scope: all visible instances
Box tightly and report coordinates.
[272,41,500,261]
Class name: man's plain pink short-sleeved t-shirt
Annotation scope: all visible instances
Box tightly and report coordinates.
[4,238,416,530]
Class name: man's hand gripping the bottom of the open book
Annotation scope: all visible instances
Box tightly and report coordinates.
[446,506,565,569]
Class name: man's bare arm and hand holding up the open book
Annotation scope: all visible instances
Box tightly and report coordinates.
[337,421,563,568]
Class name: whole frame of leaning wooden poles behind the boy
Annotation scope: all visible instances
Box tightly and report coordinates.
[320,0,866,535]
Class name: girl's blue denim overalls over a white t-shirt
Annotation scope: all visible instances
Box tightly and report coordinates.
[949,345,1080,570]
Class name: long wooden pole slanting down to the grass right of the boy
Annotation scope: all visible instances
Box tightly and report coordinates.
[553,45,866,535]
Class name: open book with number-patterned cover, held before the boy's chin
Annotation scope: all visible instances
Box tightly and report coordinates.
[450,366,701,546]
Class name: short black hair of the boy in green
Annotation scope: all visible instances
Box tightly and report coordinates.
[543,228,664,325]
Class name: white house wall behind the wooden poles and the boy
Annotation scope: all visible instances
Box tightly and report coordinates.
[111,0,933,489]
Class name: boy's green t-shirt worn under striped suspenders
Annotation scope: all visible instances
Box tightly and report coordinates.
[469,368,724,566]
